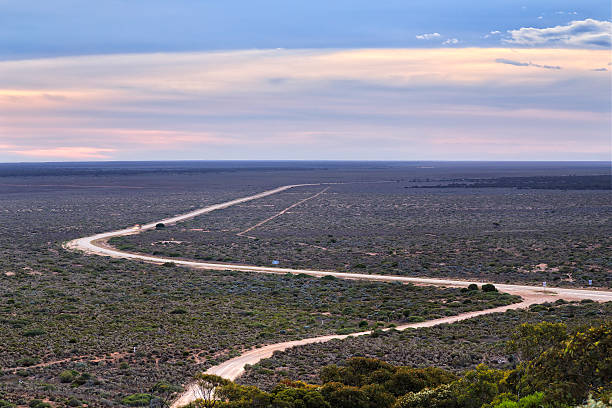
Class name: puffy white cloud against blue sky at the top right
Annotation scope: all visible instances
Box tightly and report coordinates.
[503,18,612,48]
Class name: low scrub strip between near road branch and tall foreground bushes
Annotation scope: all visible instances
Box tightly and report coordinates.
[238,301,612,390]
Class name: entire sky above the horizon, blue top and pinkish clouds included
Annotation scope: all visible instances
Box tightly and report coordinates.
[0,0,612,162]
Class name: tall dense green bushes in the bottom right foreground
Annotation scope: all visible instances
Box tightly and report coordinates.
[184,322,612,408]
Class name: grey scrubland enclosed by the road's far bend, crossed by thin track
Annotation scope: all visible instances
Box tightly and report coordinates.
[111,183,612,287]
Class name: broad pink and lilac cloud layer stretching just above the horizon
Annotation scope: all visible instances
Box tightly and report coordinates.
[0,48,611,161]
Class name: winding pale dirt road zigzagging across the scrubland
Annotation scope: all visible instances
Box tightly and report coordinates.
[64,183,612,408]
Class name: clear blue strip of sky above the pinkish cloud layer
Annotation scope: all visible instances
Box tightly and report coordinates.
[0,0,611,59]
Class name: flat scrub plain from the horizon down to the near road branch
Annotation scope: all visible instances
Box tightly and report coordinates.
[0,162,612,406]
